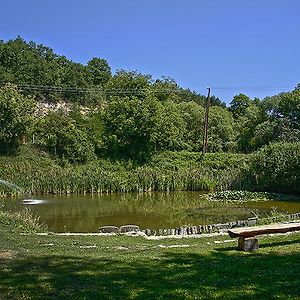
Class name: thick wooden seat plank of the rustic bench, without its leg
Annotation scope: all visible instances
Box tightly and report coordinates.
[228,222,300,238]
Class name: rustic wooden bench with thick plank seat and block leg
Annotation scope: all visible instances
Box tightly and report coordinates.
[228,222,300,251]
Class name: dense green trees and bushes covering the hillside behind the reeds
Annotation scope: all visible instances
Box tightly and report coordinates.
[0,37,300,192]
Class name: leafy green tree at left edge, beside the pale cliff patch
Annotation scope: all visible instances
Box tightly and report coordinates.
[0,84,35,151]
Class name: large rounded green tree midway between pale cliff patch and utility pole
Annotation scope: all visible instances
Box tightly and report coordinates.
[103,97,161,160]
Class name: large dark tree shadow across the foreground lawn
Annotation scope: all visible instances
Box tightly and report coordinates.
[0,251,300,299]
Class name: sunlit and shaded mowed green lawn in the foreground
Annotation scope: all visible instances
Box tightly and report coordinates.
[0,217,300,299]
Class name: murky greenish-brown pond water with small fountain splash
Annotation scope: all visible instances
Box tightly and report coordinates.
[0,192,300,232]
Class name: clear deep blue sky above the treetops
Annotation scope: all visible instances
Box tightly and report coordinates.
[0,0,300,103]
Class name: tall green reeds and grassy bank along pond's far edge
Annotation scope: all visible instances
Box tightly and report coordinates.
[0,146,249,195]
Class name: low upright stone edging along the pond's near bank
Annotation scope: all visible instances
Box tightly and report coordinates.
[99,212,300,236]
